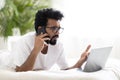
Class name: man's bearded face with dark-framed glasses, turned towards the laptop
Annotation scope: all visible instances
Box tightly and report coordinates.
[46,19,60,45]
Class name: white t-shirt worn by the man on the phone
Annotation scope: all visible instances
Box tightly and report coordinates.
[11,32,68,69]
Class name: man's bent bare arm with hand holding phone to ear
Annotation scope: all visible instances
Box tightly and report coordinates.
[15,34,49,72]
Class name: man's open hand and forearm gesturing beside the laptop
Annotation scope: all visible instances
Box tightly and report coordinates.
[65,45,91,70]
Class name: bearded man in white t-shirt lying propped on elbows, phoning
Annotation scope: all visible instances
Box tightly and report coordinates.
[13,8,91,72]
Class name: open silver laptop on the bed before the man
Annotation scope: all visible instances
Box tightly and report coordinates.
[83,47,112,72]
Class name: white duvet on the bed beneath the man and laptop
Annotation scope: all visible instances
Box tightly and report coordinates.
[0,59,120,80]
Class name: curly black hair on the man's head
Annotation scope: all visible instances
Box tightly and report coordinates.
[34,8,64,32]
